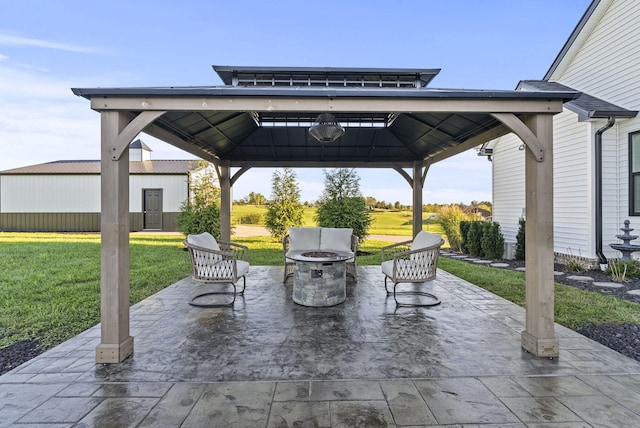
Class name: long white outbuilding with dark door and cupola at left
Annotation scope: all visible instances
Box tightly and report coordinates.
[0,140,194,232]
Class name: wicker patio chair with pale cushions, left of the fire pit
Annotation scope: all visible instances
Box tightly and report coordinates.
[184,232,249,308]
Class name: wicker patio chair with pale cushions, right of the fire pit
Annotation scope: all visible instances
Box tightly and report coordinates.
[381,231,444,306]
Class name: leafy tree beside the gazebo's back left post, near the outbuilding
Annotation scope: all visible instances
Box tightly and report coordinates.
[177,160,220,238]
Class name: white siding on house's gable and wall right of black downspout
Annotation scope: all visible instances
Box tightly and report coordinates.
[550,0,640,258]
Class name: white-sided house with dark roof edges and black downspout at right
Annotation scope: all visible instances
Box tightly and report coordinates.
[487,0,640,265]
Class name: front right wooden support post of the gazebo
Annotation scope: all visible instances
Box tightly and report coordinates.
[521,114,560,357]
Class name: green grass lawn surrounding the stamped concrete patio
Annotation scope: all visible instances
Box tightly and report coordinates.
[0,232,640,349]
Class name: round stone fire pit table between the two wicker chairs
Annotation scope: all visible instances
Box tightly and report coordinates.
[287,250,354,307]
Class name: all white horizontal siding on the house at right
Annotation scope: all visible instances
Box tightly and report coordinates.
[491,0,640,260]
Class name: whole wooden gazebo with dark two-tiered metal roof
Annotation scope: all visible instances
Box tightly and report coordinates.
[73,66,579,363]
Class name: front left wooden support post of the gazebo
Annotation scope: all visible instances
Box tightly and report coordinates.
[96,111,133,363]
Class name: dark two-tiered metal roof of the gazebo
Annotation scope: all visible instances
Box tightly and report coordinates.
[73,66,578,167]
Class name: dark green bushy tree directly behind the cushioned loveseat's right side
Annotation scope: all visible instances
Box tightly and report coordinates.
[315,168,373,241]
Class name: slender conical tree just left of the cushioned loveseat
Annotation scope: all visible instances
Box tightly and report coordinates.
[264,168,303,239]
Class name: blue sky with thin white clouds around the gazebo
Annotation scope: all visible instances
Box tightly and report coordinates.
[0,0,590,204]
